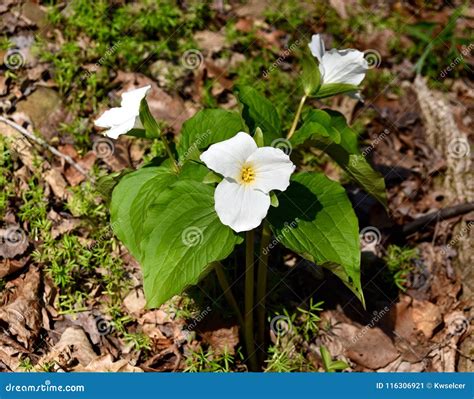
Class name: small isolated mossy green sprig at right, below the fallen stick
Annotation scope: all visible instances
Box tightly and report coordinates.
[384,245,418,291]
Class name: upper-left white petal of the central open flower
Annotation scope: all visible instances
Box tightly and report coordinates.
[200,132,257,180]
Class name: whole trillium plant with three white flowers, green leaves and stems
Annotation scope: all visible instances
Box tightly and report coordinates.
[95,35,386,370]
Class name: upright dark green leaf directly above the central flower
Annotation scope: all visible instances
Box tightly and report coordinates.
[236,86,282,145]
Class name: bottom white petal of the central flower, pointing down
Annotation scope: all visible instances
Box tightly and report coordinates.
[214,179,270,233]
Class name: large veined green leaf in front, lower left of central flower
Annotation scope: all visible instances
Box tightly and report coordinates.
[141,180,240,307]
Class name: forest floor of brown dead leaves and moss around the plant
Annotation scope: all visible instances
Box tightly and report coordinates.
[0,0,474,371]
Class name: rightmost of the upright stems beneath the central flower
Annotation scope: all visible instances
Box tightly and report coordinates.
[256,220,272,363]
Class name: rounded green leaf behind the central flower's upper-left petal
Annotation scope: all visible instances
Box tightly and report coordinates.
[177,109,245,162]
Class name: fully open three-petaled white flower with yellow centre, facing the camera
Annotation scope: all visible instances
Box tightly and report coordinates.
[201,132,295,232]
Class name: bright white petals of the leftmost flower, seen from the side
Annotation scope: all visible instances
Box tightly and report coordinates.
[94,85,151,139]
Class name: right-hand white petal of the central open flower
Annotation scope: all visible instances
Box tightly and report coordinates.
[246,147,295,193]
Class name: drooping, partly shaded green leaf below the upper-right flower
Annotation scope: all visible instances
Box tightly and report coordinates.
[290,110,387,207]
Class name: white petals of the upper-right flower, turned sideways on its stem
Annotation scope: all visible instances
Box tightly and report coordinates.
[308,35,369,86]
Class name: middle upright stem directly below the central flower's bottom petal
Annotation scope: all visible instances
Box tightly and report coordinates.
[244,230,258,371]
